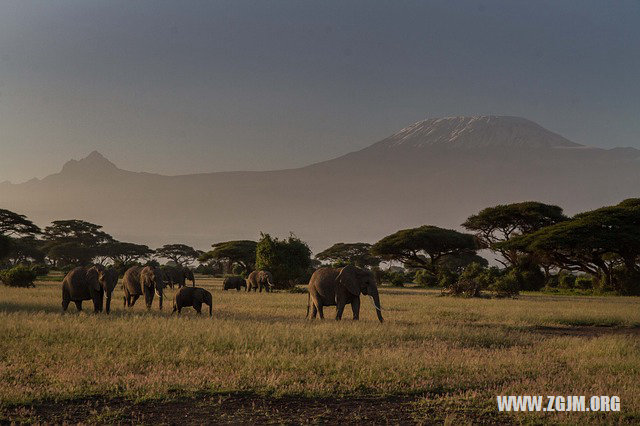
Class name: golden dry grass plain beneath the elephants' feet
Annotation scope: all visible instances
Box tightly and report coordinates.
[0,277,640,424]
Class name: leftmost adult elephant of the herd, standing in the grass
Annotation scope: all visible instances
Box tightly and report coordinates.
[62,265,118,313]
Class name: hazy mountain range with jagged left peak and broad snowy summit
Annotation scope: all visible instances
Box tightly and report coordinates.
[0,116,640,251]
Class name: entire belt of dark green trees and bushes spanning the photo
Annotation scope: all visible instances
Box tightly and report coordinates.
[0,199,640,296]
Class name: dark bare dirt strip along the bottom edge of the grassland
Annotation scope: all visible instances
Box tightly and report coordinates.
[0,395,456,425]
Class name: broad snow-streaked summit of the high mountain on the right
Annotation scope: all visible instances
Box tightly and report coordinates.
[380,115,581,149]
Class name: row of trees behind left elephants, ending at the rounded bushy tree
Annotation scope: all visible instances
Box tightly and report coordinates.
[0,209,316,287]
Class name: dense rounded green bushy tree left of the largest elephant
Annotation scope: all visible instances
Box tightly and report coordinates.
[256,234,311,287]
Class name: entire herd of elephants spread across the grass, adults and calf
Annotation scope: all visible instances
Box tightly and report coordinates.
[62,265,383,322]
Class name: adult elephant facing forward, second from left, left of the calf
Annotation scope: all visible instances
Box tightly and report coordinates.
[122,266,164,310]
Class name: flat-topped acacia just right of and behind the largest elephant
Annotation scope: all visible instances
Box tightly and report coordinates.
[371,225,478,276]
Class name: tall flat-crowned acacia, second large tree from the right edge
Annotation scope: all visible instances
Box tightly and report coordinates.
[462,201,567,266]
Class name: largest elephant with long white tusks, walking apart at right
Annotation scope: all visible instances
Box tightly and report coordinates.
[307,266,384,322]
